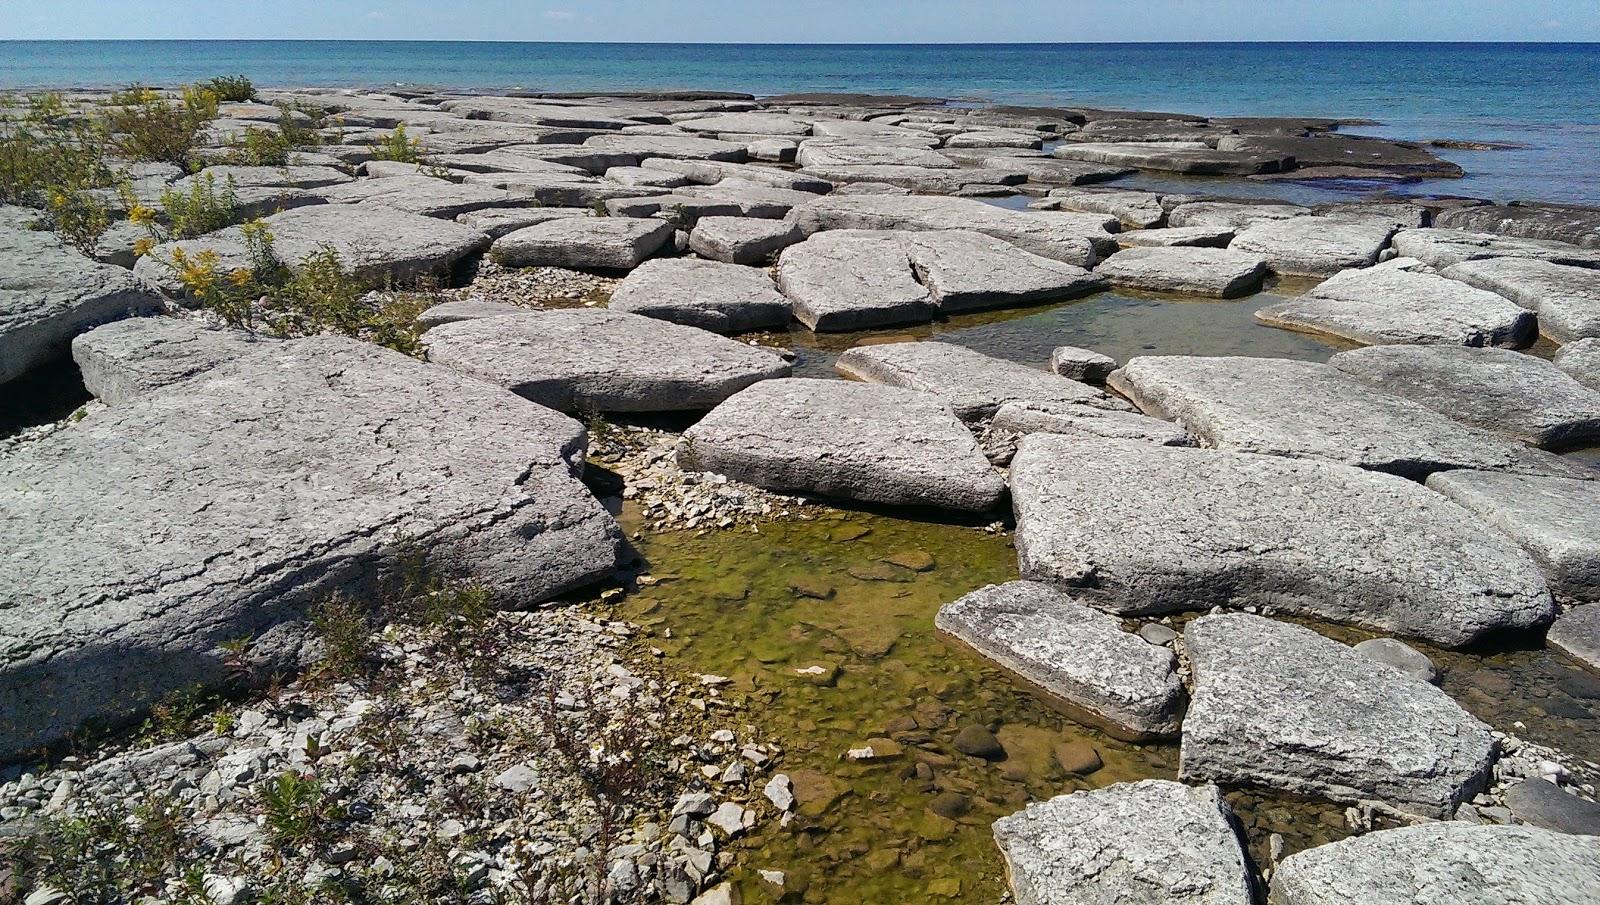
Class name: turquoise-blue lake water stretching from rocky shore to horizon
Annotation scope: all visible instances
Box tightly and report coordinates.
[0,42,1600,203]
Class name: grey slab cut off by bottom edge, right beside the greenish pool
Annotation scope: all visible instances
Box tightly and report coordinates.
[994,779,1253,905]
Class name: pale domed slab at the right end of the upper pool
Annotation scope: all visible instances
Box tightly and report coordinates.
[1254,268,1538,349]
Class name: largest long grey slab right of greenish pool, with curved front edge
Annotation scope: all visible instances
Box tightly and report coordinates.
[1011,433,1552,646]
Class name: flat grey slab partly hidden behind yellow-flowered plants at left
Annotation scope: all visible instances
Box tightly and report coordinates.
[133,206,488,296]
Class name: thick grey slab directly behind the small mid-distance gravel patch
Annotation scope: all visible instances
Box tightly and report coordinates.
[490,217,674,270]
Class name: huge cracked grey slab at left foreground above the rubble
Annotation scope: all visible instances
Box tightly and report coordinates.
[0,337,621,759]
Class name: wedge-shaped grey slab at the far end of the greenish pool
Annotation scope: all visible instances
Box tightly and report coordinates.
[678,379,1005,512]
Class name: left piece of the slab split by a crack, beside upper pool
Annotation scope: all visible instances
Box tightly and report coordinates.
[778,230,933,333]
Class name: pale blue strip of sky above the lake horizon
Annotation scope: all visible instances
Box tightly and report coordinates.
[0,0,1600,43]
